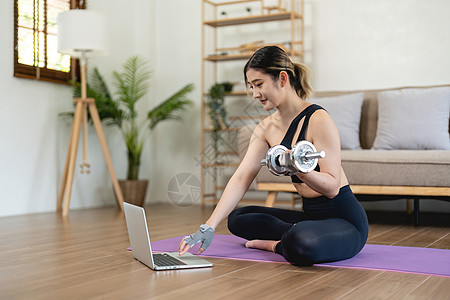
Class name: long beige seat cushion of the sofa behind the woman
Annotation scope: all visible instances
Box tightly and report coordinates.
[342,150,450,187]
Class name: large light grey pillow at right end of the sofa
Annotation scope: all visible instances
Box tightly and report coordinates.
[373,87,450,150]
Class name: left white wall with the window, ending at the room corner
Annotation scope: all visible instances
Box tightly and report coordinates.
[0,0,154,216]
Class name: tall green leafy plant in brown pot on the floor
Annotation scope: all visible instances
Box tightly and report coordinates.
[65,56,194,206]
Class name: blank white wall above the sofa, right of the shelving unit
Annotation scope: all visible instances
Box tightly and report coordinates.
[306,0,450,90]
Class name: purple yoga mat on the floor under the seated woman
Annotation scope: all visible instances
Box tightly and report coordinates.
[144,234,450,277]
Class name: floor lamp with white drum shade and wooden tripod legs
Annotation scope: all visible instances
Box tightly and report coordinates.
[57,9,123,216]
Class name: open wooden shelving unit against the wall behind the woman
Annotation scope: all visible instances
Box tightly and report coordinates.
[201,0,304,206]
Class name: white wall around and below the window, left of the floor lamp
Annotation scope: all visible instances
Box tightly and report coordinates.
[0,1,71,215]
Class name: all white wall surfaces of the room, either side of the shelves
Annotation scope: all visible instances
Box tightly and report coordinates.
[0,0,450,216]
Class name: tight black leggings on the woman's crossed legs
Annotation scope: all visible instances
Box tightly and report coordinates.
[228,185,369,265]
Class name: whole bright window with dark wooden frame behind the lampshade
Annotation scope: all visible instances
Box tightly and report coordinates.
[14,0,86,83]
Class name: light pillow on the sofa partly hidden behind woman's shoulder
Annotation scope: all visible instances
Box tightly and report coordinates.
[311,93,364,149]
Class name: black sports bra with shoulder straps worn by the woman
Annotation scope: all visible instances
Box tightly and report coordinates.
[280,104,325,183]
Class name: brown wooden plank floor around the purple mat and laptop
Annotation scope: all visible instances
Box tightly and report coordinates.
[0,205,450,300]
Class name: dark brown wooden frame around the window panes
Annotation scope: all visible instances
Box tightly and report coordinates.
[14,0,86,84]
